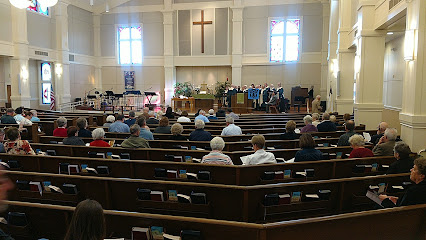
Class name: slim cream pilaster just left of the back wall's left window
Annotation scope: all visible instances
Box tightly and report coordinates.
[93,14,103,91]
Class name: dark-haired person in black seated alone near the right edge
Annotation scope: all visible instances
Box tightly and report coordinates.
[386,142,414,174]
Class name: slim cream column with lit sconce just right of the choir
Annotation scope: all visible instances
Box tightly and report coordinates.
[328,0,339,112]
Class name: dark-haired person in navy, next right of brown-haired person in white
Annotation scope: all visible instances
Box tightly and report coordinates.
[294,133,322,162]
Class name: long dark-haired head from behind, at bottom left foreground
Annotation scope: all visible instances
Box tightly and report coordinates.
[65,199,106,240]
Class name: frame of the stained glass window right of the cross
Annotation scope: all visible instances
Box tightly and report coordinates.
[267,16,303,65]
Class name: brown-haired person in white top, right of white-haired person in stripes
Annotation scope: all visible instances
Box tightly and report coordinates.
[240,135,277,165]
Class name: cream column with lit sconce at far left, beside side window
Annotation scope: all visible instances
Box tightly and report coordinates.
[10,6,31,108]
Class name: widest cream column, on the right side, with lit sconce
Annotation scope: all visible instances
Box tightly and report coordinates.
[354,1,386,129]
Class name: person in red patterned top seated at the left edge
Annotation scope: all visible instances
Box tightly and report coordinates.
[4,127,35,155]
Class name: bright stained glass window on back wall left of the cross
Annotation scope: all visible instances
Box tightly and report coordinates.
[118,27,142,64]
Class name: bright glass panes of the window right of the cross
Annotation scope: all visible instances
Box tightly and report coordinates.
[270,19,300,62]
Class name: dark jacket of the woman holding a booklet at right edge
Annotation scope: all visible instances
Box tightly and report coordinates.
[382,180,426,207]
